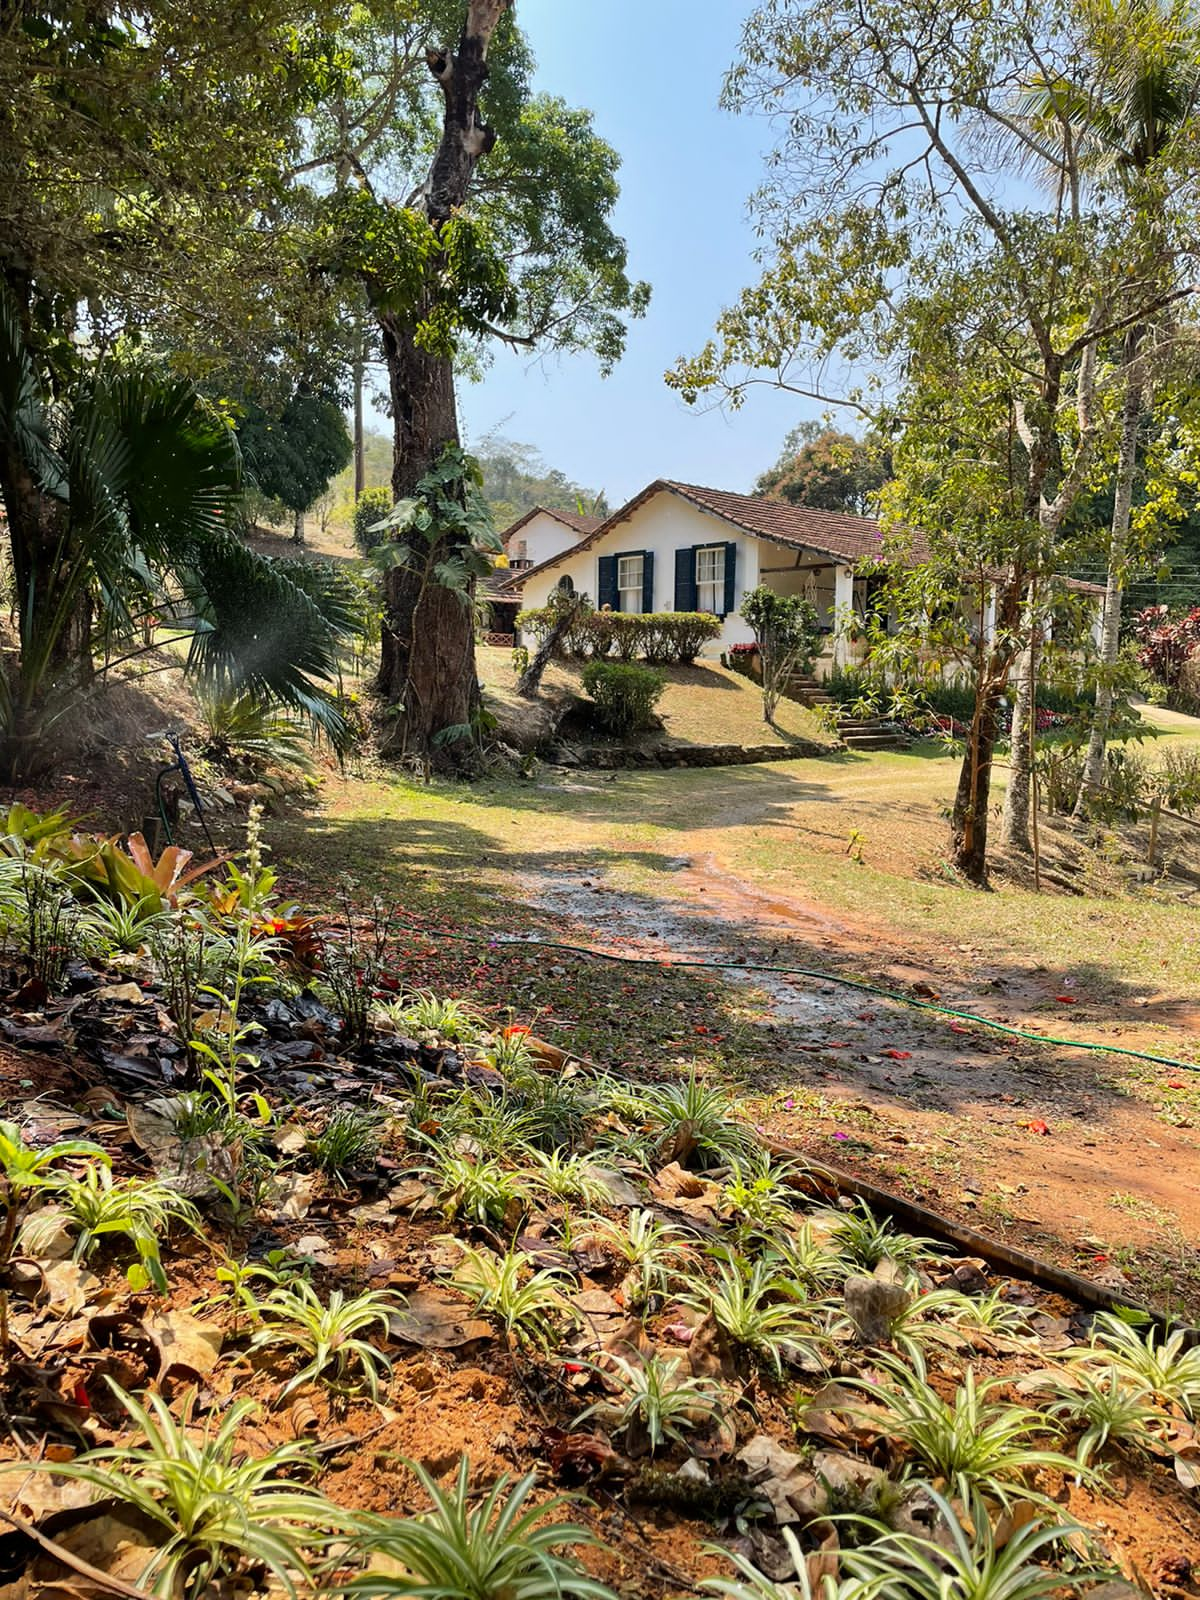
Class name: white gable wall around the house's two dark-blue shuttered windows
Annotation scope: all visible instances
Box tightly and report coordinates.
[522,490,761,656]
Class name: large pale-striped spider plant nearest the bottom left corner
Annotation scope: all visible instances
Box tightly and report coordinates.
[21,1379,349,1600]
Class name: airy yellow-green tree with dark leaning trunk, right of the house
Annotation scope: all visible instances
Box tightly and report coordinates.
[669,0,1190,882]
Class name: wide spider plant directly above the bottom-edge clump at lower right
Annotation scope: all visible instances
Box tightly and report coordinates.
[848,1360,1078,1506]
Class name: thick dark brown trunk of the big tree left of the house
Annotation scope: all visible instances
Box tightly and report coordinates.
[376,0,507,760]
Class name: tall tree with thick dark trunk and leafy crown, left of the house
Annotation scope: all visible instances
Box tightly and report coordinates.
[302,0,646,757]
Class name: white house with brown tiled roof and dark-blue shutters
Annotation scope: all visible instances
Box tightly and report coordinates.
[491,478,1102,670]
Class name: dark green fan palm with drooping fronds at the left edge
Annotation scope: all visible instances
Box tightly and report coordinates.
[0,291,350,778]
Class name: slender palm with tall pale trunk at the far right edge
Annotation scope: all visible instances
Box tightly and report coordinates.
[1016,0,1200,814]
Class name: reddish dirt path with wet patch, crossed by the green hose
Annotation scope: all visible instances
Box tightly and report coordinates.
[523,835,1200,1301]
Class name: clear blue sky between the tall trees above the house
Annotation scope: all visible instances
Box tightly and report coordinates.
[461,0,819,504]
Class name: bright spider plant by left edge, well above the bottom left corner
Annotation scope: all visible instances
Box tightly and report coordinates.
[21,1162,200,1294]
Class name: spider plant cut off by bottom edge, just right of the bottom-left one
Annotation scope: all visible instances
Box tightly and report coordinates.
[346,1456,614,1600]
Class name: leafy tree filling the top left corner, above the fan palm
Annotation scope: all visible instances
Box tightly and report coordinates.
[0,0,352,732]
